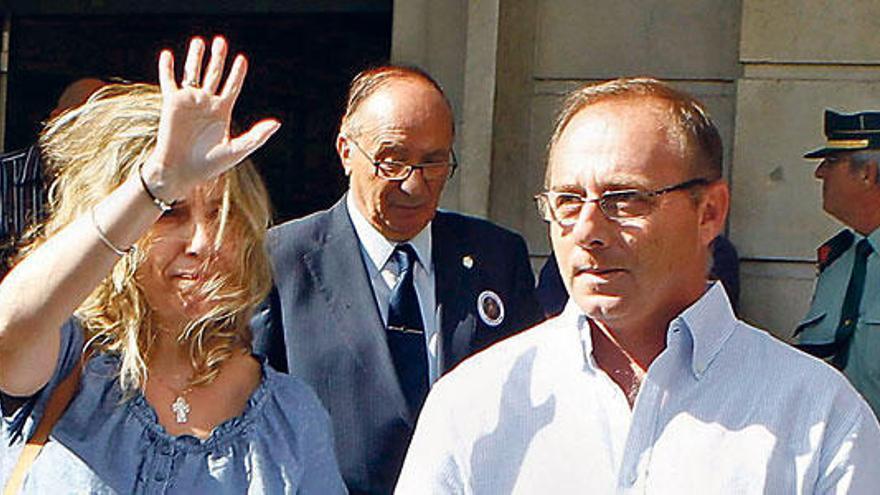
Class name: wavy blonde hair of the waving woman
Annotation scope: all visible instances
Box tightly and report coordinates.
[19,84,271,393]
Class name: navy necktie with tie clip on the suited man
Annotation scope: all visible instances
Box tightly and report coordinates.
[385,244,428,415]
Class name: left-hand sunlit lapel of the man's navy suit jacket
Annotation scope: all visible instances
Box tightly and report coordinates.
[303,201,410,418]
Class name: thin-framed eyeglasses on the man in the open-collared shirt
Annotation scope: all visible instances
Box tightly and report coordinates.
[535,177,713,227]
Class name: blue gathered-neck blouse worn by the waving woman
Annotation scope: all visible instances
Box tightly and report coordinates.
[0,320,346,495]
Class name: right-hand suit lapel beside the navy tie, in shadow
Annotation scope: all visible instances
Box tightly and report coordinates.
[431,215,476,374]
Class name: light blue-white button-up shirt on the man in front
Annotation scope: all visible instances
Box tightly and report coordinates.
[396,283,880,494]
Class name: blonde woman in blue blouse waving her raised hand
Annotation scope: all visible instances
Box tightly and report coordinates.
[0,37,345,494]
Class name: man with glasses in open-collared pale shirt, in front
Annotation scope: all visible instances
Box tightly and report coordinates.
[397,79,880,494]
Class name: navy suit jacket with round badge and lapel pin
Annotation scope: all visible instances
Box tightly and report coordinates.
[253,198,541,493]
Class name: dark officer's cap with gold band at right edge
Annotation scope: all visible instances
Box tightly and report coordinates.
[804,109,880,158]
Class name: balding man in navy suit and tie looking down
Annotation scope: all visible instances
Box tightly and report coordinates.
[254,67,541,493]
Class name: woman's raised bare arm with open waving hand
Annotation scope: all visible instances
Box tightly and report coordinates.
[0,37,280,396]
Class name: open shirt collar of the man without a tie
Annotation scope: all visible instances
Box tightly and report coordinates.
[559,282,737,380]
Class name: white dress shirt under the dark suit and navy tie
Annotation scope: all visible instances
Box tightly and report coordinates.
[345,194,440,384]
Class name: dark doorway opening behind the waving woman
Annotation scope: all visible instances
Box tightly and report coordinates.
[0,0,391,227]
